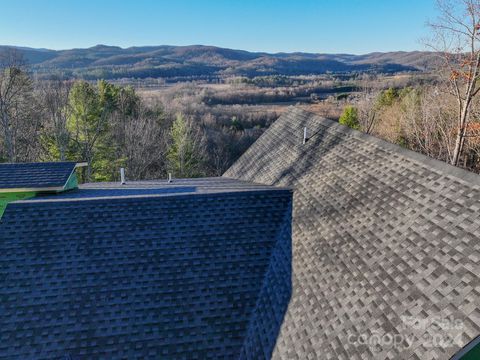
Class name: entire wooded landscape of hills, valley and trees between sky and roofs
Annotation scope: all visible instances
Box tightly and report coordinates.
[0,15,480,181]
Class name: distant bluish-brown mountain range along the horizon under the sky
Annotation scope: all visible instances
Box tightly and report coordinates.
[0,45,436,79]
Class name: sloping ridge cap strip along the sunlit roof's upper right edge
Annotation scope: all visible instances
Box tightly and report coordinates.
[287,107,480,186]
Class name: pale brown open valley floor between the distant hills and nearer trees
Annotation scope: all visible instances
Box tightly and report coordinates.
[135,73,431,124]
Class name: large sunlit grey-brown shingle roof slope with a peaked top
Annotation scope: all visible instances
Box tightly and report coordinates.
[224,109,480,359]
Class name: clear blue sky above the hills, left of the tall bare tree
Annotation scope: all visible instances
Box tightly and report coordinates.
[0,0,435,54]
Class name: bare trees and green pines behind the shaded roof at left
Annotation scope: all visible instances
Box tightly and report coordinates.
[0,50,266,182]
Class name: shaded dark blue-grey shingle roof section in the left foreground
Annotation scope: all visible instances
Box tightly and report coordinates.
[0,179,292,359]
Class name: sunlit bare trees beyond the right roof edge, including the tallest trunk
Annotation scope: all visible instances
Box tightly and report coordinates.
[340,0,480,172]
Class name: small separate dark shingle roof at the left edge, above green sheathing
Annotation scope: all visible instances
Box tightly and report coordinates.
[0,162,76,190]
